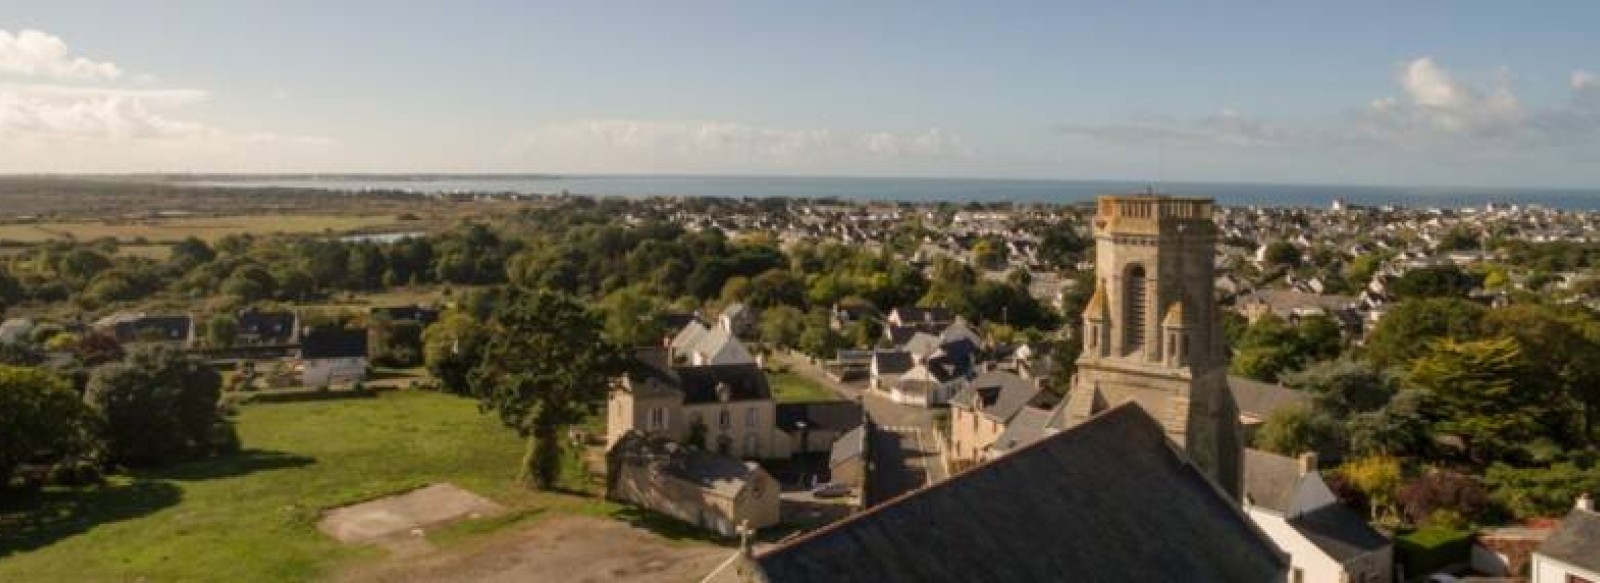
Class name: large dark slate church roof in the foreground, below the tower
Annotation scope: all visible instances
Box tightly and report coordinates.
[750,405,1288,583]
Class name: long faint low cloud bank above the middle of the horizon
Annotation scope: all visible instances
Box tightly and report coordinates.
[515,119,974,171]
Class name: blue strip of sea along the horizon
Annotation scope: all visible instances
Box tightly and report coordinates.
[190,175,1600,210]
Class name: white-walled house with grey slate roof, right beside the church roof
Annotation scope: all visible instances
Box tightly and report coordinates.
[1245,450,1394,583]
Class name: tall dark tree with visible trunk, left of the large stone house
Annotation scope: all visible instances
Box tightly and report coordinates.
[467,290,622,490]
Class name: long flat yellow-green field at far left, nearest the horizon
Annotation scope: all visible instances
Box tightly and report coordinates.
[0,215,419,243]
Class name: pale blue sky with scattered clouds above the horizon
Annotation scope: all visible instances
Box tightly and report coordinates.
[0,0,1600,187]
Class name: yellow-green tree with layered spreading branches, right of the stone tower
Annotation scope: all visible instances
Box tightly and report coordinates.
[1405,338,1547,464]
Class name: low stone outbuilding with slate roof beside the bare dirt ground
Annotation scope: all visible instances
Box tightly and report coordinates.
[606,431,781,537]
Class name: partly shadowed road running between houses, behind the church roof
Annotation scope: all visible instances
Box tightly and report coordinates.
[771,352,949,506]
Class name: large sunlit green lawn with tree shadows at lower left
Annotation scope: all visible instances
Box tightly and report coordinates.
[0,391,531,581]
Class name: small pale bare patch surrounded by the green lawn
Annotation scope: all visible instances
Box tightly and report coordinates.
[317,484,502,543]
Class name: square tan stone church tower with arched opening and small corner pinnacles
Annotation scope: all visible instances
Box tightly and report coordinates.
[1056,195,1243,498]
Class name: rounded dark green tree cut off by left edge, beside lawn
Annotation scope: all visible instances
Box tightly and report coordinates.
[0,365,99,489]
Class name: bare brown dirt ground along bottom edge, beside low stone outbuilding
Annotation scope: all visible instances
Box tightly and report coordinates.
[334,516,733,583]
